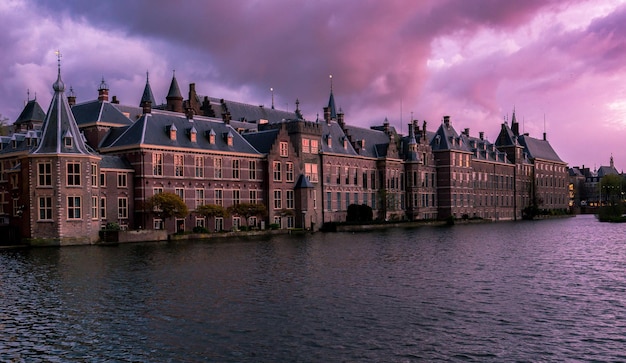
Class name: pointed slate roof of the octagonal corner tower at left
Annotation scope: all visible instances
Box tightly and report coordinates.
[32,68,94,155]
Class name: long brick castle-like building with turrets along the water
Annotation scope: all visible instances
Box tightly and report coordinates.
[0,67,568,245]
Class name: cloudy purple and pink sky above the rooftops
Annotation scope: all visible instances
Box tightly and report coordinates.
[0,0,626,171]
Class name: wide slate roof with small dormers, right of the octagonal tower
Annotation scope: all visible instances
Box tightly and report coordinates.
[107,110,258,154]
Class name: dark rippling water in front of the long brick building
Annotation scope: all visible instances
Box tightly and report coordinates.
[0,216,626,362]
